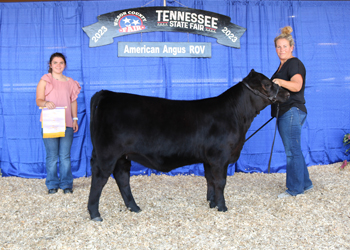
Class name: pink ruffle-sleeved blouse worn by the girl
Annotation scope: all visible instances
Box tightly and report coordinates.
[40,73,81,127]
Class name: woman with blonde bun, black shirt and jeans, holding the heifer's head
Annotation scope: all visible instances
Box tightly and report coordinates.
[271,26,313,198]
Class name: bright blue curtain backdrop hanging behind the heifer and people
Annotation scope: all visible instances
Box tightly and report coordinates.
[0,0,350,178]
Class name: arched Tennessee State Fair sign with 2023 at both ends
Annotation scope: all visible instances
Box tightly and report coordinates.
[82,7,246,48]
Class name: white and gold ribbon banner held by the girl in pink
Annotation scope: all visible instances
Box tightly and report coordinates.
[42,107,66,138]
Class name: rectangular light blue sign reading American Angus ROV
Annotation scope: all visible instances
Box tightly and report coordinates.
[118,42,211,57]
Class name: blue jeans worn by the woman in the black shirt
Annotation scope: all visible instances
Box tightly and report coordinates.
[278,107,312,196]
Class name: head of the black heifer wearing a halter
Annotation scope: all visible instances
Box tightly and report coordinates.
[242,69,290,103]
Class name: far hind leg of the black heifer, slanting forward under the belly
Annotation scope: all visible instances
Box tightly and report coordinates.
[113,156,141,213]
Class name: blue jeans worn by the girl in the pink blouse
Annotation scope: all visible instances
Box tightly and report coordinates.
[41,127,74,189]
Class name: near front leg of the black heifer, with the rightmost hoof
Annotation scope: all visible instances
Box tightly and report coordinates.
[212,164,228,212]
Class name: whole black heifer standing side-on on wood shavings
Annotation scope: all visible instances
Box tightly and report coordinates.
[88,70,289,221]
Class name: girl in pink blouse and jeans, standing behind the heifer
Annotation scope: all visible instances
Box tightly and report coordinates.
[36,52,81,194]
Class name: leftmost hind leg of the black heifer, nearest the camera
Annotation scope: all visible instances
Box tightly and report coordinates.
[88,169,108,221]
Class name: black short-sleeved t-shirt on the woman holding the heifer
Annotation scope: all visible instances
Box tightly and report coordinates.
[271,57,307,117]
